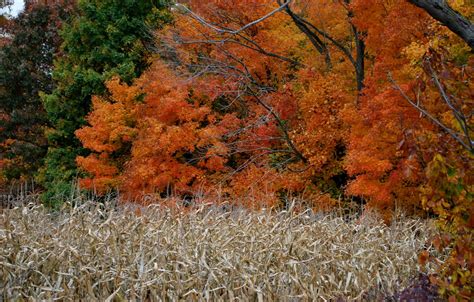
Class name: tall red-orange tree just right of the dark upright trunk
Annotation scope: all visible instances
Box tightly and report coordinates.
[346,1,432,218]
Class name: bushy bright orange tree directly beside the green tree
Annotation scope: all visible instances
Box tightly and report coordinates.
[76,61,234,202]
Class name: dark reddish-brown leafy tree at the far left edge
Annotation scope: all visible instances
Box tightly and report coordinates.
[0,5,74,184]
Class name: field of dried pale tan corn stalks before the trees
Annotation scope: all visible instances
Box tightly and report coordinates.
[0,204,436,301]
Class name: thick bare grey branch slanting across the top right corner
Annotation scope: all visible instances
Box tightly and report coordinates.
[408,0,474,49]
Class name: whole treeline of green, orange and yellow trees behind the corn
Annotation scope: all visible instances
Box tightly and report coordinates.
[0,0,474,299]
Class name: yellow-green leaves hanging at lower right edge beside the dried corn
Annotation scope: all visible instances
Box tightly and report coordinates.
[423,150,474,299]
